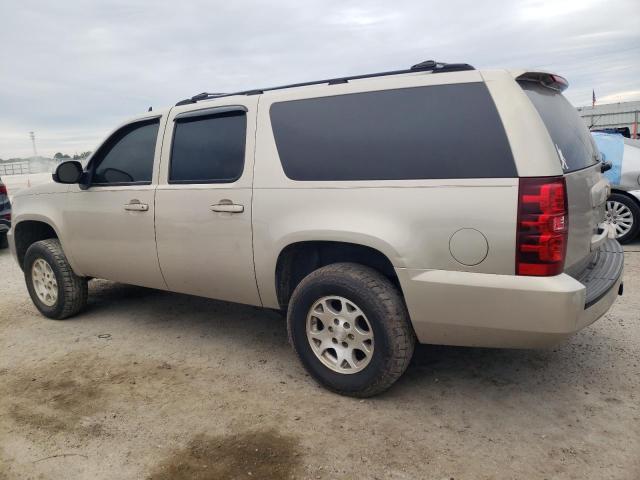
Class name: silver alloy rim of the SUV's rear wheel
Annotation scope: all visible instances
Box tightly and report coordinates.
[306,296,374,374]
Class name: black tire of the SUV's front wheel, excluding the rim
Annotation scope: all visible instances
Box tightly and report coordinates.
[24,238,88,320]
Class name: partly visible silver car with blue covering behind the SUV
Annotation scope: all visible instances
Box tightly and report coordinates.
[591,132,640,243]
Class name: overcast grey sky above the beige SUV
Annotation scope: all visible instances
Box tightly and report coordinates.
[0,0,640,158]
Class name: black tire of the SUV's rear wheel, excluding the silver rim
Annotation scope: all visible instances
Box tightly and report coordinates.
[287,263,415,398]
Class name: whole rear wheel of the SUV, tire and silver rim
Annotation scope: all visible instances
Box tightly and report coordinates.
[287,263,415,397]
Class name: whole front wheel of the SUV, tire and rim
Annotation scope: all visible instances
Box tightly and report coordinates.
[24,238,87,320]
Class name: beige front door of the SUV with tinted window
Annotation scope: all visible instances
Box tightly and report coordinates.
[63,117,166,289]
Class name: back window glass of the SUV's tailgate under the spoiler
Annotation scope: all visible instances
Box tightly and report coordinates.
[520,82,597,172]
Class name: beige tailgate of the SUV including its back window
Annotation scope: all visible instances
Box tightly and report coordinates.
[520,81,609,272]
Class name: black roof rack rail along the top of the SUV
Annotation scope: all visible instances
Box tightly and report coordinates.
[176,60,475,106]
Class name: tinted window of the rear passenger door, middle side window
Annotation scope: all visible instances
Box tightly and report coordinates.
[169,112,247,183]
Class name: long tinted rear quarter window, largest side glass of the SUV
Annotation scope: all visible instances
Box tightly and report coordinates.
[270,83,517,180]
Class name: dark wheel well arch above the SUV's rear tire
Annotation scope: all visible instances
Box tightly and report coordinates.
[276,241,400,309]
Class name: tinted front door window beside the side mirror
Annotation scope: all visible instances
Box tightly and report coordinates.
[92,120,160,184]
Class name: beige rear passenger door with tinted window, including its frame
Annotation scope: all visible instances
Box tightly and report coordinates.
[156,98,261,305]
